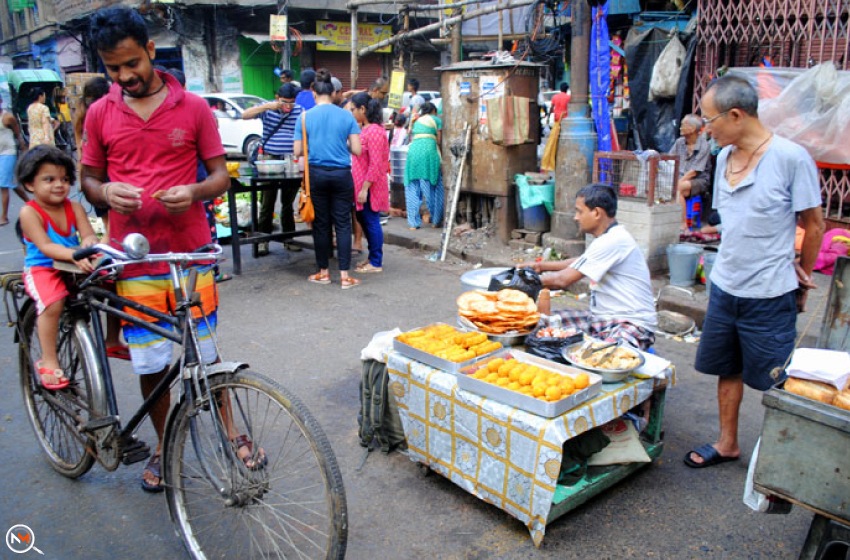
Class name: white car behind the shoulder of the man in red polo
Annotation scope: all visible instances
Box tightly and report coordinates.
[200,93,267,157]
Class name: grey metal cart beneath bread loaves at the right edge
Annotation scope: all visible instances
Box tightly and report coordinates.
[753,257,850,560]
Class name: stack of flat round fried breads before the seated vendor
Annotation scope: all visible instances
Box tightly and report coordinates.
[457,290,540,334]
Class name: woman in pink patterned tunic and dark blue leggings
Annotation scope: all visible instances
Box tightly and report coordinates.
[349,92,390,274]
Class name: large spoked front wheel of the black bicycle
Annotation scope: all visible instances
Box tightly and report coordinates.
[163,371,348,560]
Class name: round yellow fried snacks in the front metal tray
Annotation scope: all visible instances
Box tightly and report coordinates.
[469,358,590,402]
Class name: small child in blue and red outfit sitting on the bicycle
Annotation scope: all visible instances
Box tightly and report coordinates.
[16,145,98,390]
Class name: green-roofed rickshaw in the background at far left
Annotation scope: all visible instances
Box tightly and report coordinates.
[8,68,75,153]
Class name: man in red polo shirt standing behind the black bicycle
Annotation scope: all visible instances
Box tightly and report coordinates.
[82,8,232,492]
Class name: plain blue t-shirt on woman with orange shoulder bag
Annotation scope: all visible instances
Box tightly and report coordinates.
[295,103,360,168]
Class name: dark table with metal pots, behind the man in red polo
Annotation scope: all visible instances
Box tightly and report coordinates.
[227,175,313,274]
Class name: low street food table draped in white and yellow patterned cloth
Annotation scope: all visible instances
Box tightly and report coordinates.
[387,300,675,545]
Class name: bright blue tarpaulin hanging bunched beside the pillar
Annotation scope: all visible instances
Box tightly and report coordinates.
[590,2,611,156]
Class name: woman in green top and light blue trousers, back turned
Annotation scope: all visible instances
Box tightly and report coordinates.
[404,103,443,229]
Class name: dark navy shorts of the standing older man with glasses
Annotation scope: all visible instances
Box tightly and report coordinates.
[695,284,797,391]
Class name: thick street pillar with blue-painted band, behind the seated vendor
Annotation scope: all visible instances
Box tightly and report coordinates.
[550,0,596,240]
